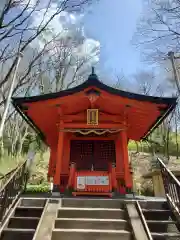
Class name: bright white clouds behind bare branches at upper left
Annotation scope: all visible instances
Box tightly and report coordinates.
[29,0,100,63]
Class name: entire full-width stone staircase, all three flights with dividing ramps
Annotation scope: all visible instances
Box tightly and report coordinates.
[0,198,180,240]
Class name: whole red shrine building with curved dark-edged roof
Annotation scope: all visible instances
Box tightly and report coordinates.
[12,73,177,197]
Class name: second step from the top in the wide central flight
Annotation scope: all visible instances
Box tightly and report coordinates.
[57,208,127,219]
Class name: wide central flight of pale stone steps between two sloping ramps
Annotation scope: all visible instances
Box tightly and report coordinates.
[52,199,133,240]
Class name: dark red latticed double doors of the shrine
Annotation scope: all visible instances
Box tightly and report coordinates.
[70,140,115,171]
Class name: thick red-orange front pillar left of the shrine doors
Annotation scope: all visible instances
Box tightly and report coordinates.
[54,131,64,185]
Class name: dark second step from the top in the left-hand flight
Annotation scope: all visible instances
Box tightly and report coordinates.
[14,206,44,217]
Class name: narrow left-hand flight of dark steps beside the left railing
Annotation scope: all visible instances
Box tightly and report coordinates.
[0,199,46,240]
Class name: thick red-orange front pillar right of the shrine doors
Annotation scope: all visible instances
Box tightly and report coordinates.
[120,131,132,189]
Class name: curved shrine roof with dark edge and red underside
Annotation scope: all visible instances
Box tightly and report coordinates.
[12,74,177,144]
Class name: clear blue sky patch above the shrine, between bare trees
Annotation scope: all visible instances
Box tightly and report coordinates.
[84,0,145,76]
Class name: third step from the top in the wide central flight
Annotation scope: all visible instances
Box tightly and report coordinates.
[55,218,129,230]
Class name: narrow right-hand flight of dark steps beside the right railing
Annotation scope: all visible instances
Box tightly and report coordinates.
[140,201,180,240]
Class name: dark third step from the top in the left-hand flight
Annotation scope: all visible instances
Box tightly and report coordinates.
[8,217,40,229]
